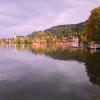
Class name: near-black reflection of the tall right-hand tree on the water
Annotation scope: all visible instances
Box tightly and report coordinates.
[85,53,100,85]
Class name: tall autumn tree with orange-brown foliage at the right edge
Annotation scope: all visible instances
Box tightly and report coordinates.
[84,7,100,43]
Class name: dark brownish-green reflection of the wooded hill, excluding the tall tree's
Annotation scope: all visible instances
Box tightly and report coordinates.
[47,48,85,61]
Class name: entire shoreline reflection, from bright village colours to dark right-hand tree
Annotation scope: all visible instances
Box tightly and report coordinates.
[0,44,100,85]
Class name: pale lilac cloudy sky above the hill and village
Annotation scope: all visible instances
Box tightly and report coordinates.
[0,0,100,37]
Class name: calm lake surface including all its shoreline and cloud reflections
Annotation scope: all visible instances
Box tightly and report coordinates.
[0,45,100,100]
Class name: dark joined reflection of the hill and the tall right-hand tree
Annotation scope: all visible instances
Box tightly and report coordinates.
[49,48,100,86]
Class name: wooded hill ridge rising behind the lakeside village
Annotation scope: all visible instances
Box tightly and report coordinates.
[28,22,85,37]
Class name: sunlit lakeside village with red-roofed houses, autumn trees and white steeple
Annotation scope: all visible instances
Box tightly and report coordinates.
[0,32,80,47]
